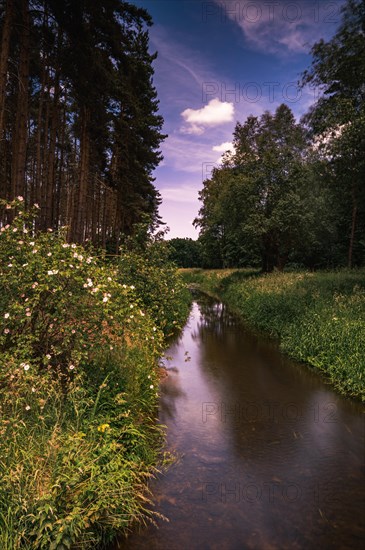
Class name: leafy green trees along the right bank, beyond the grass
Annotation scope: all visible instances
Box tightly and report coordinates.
[194,0,365,271]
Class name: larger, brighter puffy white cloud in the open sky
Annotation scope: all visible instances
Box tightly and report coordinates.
[181,98,234,135]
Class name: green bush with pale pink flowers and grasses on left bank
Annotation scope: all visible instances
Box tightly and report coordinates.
[0,201,187,550]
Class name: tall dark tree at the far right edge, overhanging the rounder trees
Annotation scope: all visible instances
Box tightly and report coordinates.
[302,0,365,267]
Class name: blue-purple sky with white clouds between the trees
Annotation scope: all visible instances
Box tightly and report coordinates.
[132,0,343,238]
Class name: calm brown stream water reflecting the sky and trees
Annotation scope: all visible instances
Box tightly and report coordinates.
[114,298,365,550]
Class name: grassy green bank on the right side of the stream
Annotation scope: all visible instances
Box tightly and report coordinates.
[182,269,365,401]
